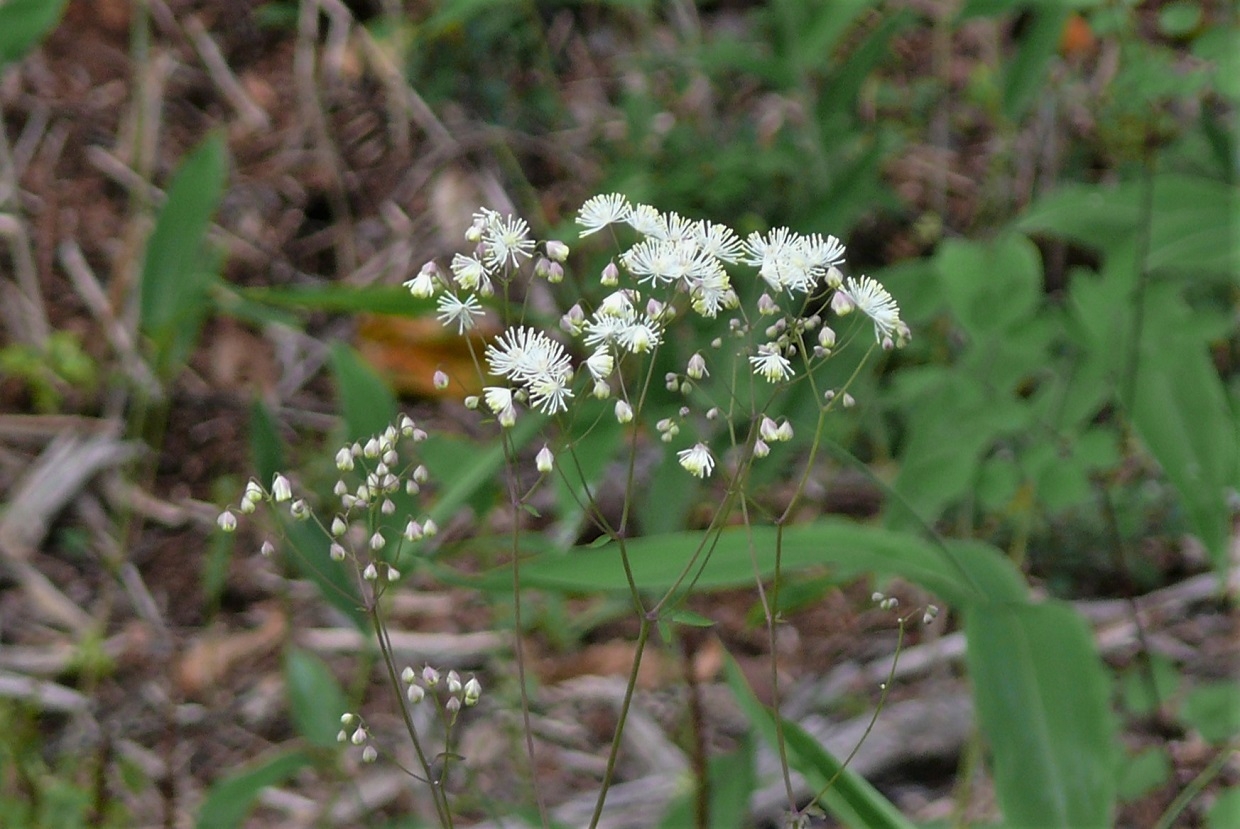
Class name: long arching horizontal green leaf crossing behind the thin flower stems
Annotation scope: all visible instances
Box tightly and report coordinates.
[484,518,1025,605]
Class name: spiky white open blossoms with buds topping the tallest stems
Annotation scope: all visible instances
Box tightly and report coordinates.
[405,193,909,477]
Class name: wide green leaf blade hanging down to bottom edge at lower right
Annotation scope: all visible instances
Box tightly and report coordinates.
[965,602,1116,829]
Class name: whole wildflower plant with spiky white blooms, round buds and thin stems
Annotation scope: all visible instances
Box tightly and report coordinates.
[219,193,909,827]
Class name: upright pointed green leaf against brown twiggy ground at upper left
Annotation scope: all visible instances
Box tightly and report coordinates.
[139,133,227,378]
